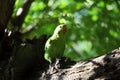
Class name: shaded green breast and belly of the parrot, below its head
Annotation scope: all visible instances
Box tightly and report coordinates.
[46,38,65,61]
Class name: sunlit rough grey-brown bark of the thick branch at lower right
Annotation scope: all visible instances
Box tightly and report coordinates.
[39,49,120,80]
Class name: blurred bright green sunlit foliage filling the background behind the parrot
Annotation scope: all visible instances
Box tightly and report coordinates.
[13,0,120,61]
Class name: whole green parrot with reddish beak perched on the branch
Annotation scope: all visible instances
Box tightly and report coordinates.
[44,25,67,63]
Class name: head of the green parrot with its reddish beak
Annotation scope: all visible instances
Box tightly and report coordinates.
[54,24,67,35]
